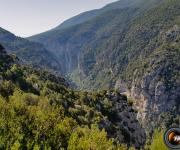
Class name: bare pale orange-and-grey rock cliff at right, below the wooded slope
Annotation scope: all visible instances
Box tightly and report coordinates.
[115,65,180,122]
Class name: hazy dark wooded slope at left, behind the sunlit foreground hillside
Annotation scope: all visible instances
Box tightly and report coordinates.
[0,28,61,72]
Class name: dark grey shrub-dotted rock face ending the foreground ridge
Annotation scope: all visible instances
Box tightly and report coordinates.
[99,92,146,149]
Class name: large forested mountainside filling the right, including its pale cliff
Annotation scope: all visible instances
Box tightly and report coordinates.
[27,0,180,120]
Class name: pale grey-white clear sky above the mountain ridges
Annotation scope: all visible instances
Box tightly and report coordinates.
[0,0,117,37]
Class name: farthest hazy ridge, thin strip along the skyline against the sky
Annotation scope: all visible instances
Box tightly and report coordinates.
[28,0,162,43]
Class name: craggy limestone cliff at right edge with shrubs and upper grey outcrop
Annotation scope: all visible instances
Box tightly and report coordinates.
[115,25,180,121]
